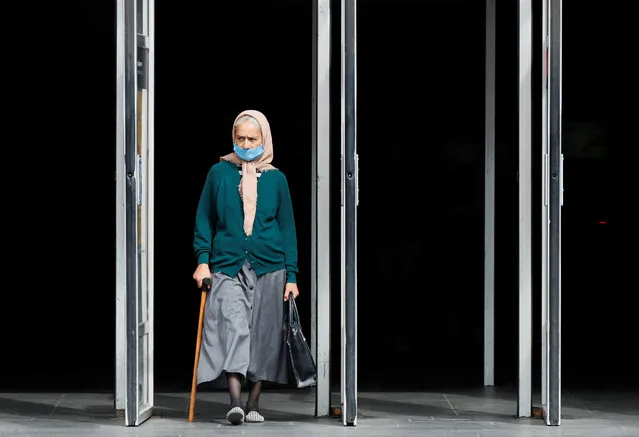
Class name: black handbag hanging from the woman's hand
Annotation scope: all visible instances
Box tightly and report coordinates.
[286,293,317,388]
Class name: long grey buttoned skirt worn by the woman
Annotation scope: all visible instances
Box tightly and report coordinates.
[197,261,289,387]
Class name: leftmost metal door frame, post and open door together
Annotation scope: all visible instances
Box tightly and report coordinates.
[115,0,154,426]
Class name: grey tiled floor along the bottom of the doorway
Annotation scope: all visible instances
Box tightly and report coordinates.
[0,388,639,437]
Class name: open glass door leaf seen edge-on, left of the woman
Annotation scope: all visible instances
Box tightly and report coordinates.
[123,0,153,426]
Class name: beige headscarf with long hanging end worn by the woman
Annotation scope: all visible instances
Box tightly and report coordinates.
[220,109,275,236]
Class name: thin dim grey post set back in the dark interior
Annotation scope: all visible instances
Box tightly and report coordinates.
[484,0,496,386]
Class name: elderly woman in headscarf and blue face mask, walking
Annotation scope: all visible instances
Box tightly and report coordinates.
[193,110,299,425]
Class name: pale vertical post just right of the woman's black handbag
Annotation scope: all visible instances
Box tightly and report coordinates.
[311,0,331,416]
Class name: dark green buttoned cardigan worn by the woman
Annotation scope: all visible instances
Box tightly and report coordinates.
[193,161,298,282]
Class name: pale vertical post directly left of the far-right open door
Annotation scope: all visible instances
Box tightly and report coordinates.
[517,0,532,417]
